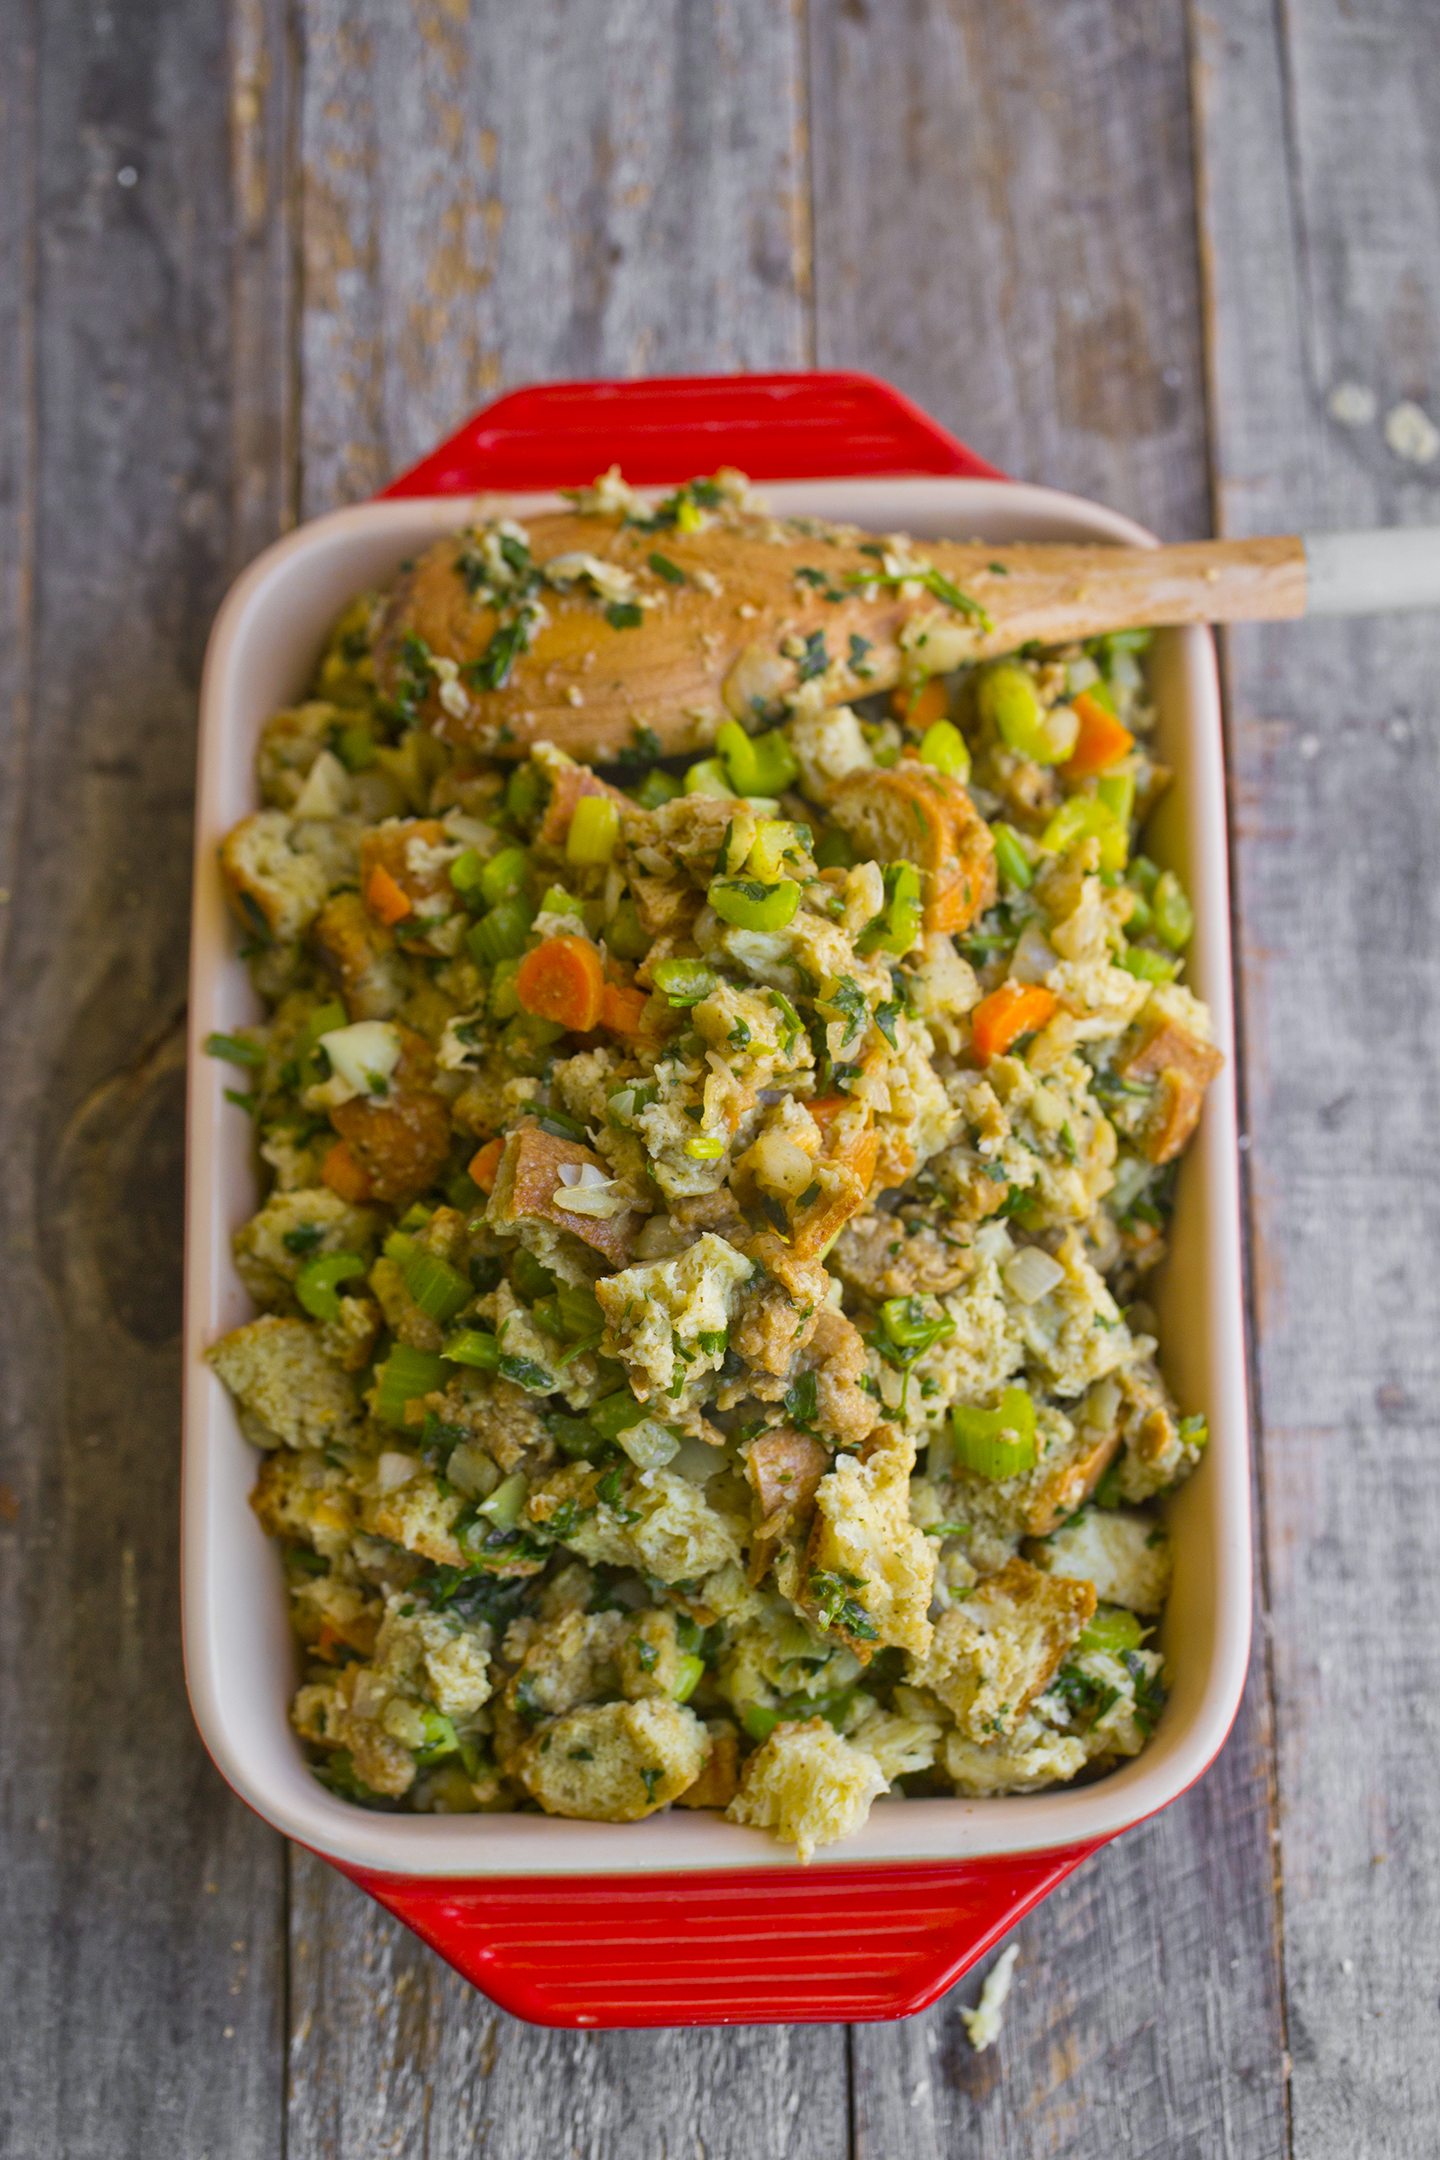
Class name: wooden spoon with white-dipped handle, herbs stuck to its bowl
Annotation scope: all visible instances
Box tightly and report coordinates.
[376,510,1440,762]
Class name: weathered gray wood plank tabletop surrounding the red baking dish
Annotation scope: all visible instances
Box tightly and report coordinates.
[0,0,1440,2160]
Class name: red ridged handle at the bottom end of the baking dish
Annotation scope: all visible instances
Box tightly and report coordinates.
[326,1840,1103,2030]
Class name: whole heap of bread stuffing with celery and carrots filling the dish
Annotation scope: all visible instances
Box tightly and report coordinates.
[209,505,1220,1855]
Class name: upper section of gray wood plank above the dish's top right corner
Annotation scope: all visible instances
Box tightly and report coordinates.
[810,0,1209,538]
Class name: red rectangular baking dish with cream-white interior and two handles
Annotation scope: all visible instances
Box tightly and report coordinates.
[184,376,1250,2026]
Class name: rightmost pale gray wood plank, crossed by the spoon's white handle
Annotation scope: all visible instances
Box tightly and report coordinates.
[1196,0,1440,2160]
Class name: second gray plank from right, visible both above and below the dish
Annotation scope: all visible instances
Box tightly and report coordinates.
[810,0,1285,2160]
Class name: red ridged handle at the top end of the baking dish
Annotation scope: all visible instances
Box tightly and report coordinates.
[382,372,1006,497]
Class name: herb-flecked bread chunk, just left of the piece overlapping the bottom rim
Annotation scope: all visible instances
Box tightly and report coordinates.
[512,1702,706,1823]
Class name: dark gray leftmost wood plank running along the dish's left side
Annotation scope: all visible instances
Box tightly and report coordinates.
[0,0,285,2160]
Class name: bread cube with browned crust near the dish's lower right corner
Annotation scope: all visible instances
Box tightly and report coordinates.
[915,1560,1095,1741]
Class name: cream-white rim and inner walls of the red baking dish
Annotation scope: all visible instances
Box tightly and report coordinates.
[184,480,1250,1877]
